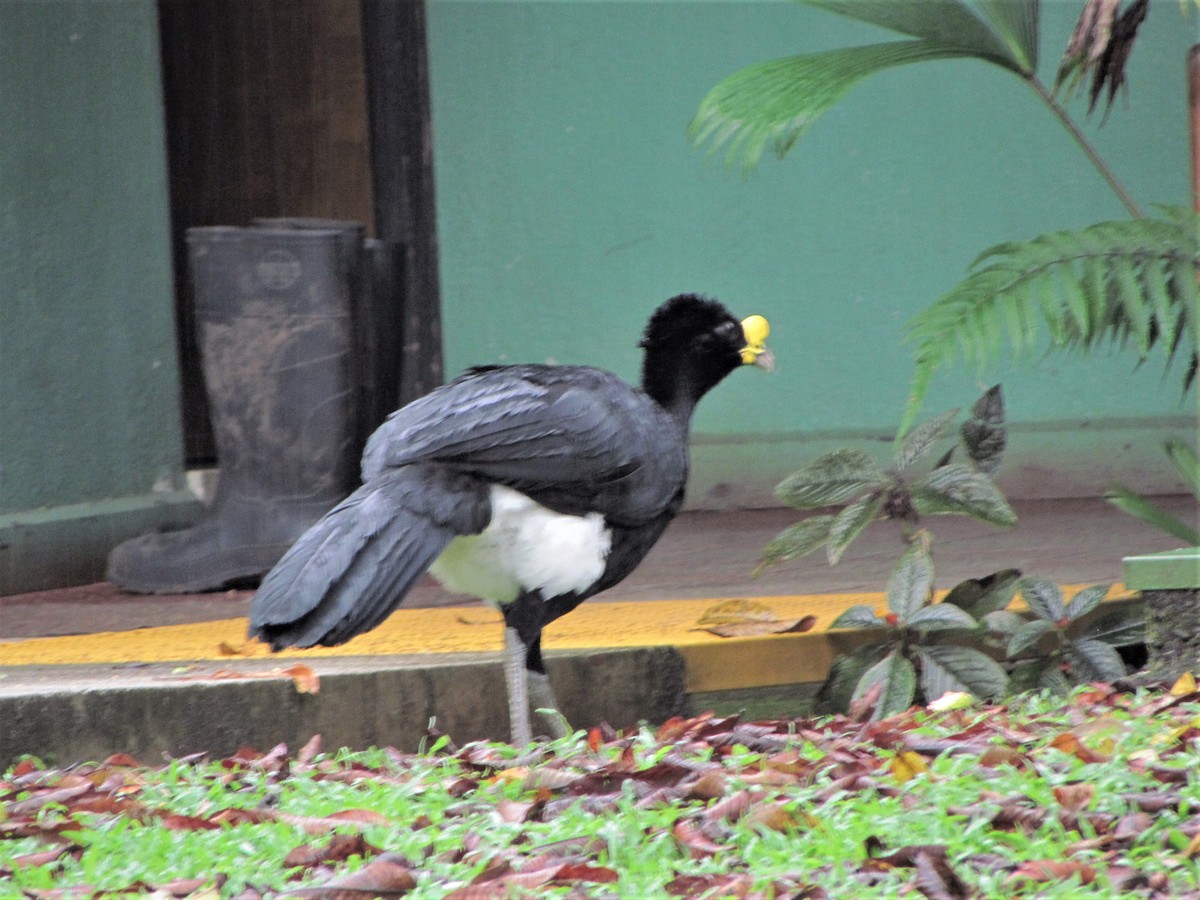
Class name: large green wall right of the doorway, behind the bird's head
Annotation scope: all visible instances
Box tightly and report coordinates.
[428,0,1195,505]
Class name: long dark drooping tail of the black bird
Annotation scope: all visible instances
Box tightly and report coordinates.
[250,466,491,649]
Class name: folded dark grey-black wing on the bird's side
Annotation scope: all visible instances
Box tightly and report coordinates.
[362,366,686,521]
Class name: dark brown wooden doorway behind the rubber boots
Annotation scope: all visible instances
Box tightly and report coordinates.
[158,0,442,466]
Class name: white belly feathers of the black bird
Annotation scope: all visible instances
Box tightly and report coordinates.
[430,485,612,605]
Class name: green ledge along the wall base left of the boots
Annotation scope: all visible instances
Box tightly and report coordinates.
[0,491,203,595]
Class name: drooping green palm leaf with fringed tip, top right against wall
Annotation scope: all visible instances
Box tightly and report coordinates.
[688,40,971,169]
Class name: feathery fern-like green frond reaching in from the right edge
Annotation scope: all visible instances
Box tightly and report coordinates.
[900,208,1200,434]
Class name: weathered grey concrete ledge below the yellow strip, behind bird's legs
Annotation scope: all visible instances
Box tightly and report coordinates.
[0,647,685,768]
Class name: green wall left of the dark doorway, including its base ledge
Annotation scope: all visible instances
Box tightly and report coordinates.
[0,0,194,593]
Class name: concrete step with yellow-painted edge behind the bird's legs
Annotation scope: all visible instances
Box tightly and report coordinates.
[0,586,1130,766]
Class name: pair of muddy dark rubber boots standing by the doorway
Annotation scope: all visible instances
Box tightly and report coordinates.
[107,220,400,594]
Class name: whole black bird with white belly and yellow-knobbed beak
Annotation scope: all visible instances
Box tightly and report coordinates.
[250,294,774,744]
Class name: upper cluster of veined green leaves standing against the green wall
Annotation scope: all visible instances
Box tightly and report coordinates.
[756,384,1016,571]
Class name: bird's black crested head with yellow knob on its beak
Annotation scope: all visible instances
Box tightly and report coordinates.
[641,294,775,413]
